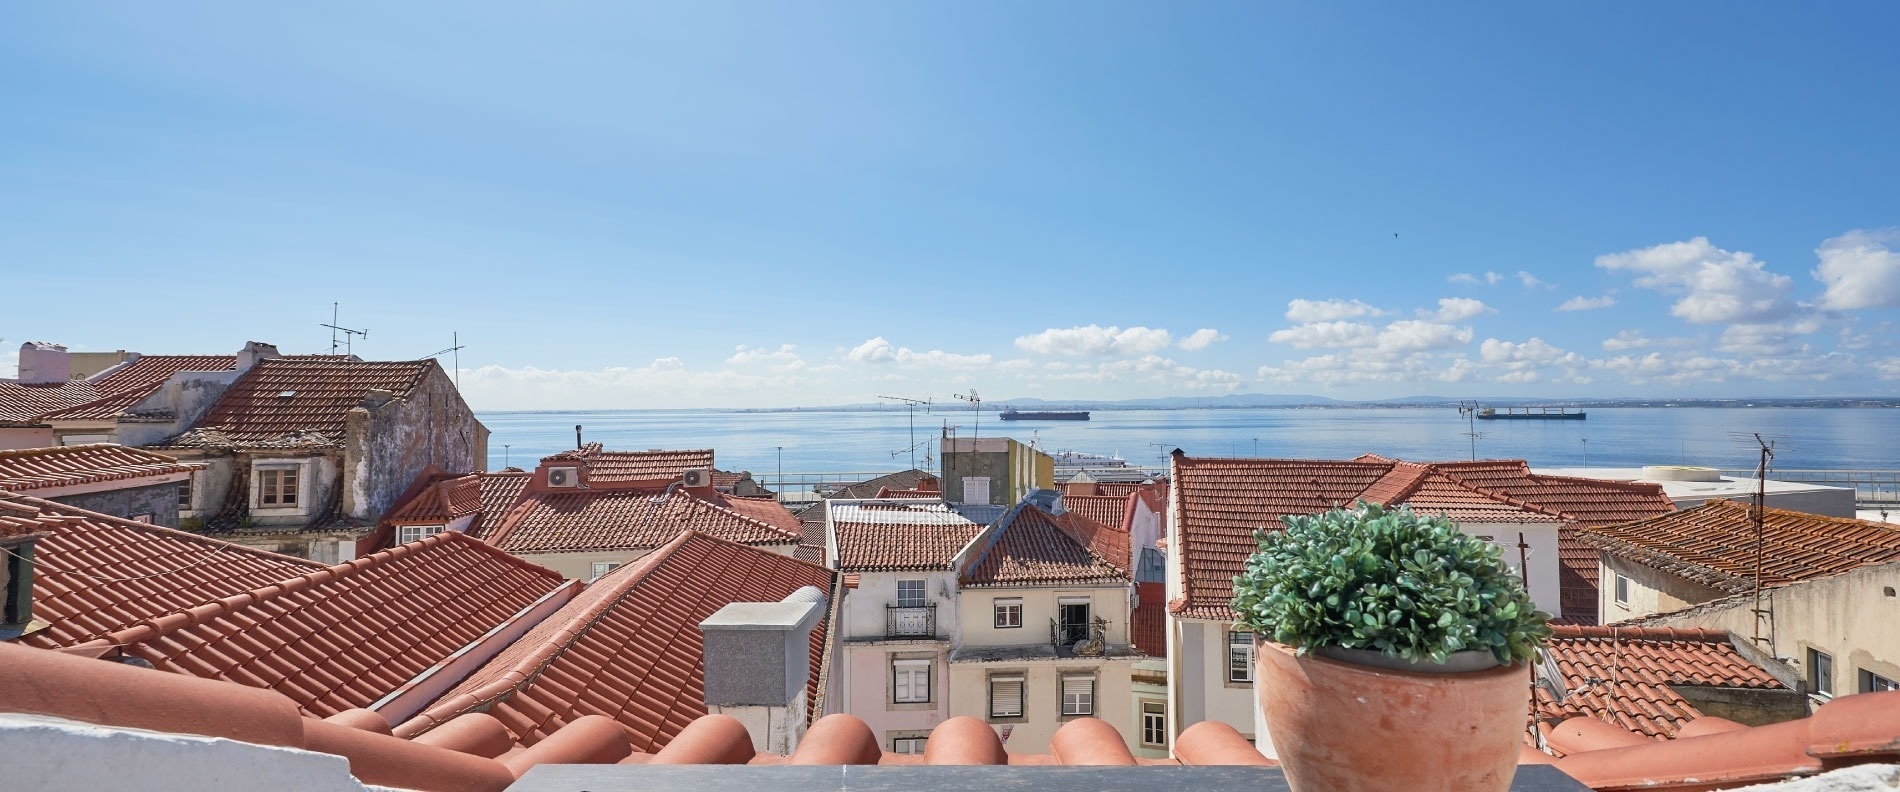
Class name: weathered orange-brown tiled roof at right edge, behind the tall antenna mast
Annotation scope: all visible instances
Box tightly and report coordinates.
[1579,500,1900,593]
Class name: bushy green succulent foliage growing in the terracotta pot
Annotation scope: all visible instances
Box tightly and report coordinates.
[1233,501,1550,665]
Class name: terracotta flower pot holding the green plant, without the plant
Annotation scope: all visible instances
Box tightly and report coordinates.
[1254,640,1530,792]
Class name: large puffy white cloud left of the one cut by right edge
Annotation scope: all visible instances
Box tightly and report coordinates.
[1596,237,1794,325]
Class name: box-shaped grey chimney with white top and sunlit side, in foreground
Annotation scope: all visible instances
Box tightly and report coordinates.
[699,585,825,756]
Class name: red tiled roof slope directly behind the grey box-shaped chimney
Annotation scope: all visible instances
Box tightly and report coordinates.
[397,532,836,752]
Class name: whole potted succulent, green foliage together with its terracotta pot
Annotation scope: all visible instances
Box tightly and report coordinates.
[1233,501,1550,792]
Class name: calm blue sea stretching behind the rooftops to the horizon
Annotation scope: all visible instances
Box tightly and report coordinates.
[477,406,1900,473]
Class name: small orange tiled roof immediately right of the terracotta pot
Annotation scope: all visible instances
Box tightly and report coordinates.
[1537,625,1786,739]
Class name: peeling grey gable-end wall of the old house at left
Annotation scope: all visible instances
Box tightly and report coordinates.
[342,365,488,520]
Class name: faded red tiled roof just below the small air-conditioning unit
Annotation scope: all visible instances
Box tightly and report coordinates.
[488,490,800,553]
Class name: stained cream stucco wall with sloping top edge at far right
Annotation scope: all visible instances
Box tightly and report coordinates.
[1644,562,1900,695]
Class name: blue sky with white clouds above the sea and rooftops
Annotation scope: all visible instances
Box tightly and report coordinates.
[0,2,1900,408]
